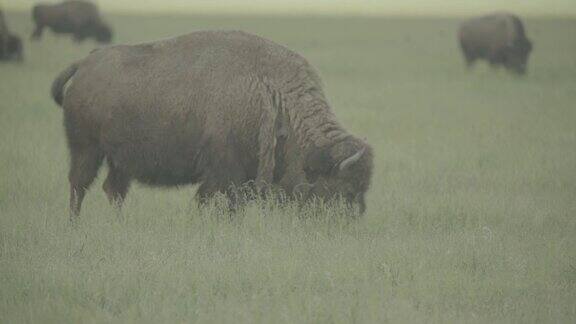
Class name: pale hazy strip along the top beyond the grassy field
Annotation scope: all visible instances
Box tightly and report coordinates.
[1,0,576,16]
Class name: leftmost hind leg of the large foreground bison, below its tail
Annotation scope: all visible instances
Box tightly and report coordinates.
[68,146,104,221]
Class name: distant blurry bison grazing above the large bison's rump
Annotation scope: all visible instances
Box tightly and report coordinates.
[32,0,112,43]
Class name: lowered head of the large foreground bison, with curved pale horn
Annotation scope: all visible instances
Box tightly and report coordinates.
[304,140,373,214]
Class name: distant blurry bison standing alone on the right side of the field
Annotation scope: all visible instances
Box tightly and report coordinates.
[458,13,532,74]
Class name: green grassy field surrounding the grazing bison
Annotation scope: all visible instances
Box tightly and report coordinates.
[0,13,576,323]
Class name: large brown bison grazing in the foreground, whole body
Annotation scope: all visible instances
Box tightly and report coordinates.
[52,31,373,218]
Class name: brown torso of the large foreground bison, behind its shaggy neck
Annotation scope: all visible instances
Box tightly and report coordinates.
[63,32,305,185]
